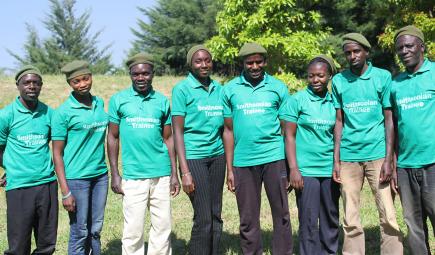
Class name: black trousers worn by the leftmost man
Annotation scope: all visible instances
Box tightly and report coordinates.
[4,181,58,255]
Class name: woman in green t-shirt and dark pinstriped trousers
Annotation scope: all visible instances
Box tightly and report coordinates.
[171,45,225,255]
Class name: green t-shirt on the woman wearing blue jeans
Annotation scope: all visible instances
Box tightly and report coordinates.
[51,94,109,179]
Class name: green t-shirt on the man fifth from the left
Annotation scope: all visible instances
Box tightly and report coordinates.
[222,74,288,167]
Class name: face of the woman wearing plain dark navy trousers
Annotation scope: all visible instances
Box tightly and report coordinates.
[308,62,331,93]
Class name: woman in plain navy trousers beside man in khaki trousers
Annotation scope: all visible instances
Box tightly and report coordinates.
[283,55,340,255]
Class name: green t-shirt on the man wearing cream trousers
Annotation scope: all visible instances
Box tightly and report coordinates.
[109,87,171,180]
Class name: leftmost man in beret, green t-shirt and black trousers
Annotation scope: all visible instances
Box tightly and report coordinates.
[0,66,58,255]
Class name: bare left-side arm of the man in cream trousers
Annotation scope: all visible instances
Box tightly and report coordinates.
[107,122,124,195]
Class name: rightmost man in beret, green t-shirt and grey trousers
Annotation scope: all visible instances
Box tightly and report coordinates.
[391,26,435,255]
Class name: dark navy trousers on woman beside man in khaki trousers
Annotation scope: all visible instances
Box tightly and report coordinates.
[296,176,340,255]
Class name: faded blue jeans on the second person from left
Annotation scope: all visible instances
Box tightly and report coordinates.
[67,173,108,255]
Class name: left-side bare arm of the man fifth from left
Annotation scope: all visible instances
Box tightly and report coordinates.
[222,118,236,193]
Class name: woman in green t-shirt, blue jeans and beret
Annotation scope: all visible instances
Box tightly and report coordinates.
[51,60,108,255]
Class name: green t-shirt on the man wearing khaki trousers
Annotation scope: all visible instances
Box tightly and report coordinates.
[332,63,391,162]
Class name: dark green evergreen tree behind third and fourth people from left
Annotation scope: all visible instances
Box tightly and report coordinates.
[129,0,219,74]
